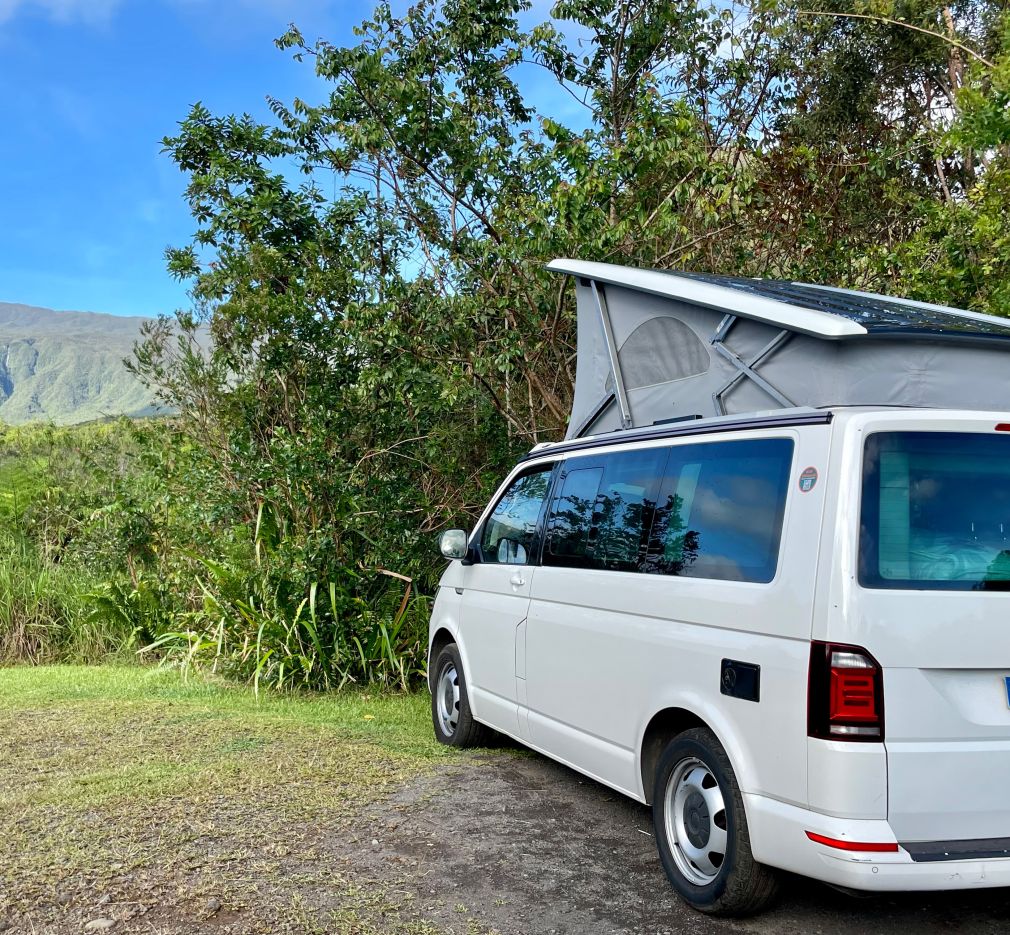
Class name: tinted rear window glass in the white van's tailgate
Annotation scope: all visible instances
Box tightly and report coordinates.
[860,432,1010,591]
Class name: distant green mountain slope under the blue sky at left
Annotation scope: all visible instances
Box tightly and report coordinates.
[0,302,153,425]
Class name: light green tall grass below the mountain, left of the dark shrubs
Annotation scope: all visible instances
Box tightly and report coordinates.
[0,420,167,662]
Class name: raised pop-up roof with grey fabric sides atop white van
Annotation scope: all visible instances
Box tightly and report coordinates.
[547,259,1010,438]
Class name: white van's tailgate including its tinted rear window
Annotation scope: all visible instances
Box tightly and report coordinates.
[847,418,1010,844]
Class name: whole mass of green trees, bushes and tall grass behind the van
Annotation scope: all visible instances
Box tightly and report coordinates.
[0,0,1010,689]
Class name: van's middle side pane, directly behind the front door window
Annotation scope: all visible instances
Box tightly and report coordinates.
[543,448,669,572]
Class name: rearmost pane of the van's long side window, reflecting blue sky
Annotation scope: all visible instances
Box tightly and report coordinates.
[644,438,793,583]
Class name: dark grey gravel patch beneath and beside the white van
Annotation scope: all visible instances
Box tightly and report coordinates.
[337,752,1010,935]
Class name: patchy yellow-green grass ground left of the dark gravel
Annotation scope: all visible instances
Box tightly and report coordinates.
[0,666,483,935]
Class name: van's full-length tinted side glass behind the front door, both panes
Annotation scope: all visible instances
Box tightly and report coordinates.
[543,438,793,582]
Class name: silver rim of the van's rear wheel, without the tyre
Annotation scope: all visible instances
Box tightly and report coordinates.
[664,756,729,887]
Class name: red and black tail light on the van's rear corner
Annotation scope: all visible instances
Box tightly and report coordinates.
[807,641,884,742]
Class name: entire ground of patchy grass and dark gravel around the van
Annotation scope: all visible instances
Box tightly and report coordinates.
[0,670,1010,935]
